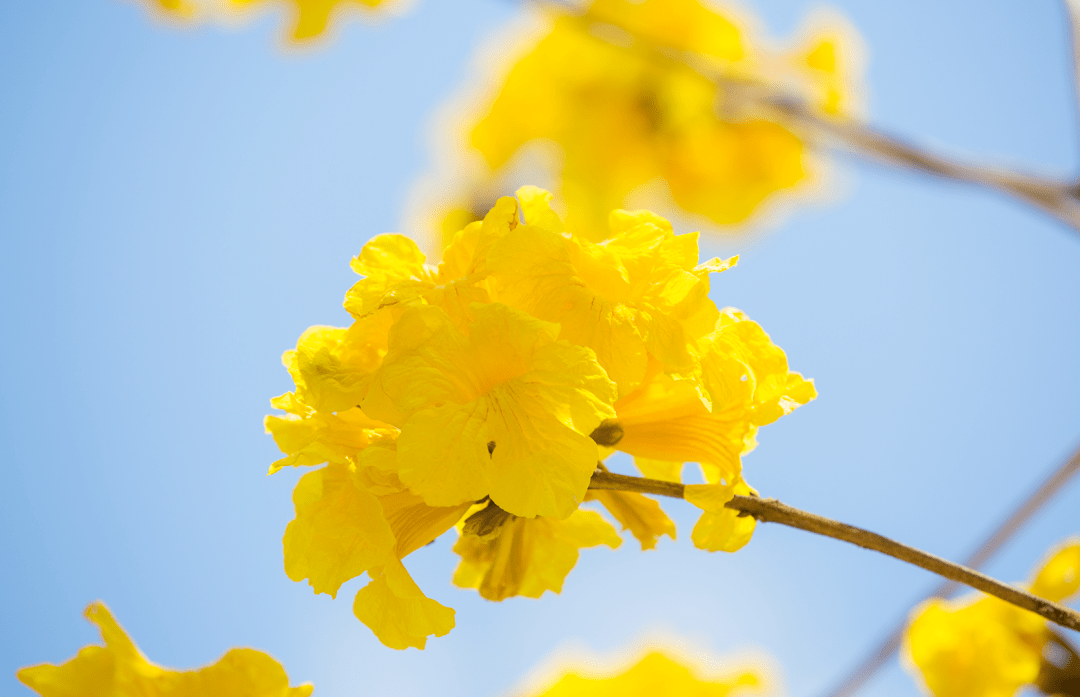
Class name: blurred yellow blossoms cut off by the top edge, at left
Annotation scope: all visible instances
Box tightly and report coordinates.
[136,0,393,42]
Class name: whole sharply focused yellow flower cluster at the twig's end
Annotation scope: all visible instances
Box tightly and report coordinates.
[266,187,814,648]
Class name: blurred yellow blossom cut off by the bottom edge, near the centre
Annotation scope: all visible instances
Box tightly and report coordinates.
[531,652,765,697]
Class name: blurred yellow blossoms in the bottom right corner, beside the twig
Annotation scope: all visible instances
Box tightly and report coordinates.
[904,538,1080,697]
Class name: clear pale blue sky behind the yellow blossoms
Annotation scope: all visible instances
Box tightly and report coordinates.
[0,0,1080,697]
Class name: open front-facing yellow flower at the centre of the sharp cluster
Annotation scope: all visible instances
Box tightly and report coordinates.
[363,304,615,518]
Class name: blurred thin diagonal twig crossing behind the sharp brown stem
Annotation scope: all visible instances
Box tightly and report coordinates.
[826,446,1080,697]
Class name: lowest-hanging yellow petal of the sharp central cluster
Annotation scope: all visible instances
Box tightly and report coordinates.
[352,559,454,649]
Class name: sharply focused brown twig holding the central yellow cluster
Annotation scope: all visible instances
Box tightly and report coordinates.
[590,471,1080,631]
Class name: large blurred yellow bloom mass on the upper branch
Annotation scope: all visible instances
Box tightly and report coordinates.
[470,0,847,233]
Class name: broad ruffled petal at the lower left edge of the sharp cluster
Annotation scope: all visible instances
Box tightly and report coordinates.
[283,465,396,595]
